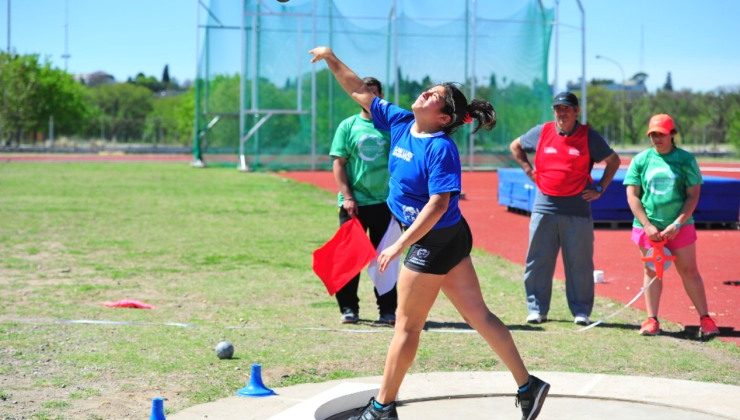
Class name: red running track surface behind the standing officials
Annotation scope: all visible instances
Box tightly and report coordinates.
[280,170,740,344]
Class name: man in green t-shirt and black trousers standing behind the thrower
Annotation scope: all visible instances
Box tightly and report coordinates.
[329,77,397,324]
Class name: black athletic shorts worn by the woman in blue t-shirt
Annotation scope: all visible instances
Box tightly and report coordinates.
[403,217,473,274]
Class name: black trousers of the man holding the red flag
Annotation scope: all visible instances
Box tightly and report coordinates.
[335,203,398,314]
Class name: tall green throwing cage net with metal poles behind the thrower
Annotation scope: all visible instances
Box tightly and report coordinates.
[193,0,553,170]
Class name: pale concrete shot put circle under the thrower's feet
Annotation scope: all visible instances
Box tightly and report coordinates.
[167,371,740,420]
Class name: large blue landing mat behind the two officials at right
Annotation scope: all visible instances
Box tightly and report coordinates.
[498,168,740,223]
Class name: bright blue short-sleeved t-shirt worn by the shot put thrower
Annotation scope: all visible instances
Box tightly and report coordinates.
[370,97,462,229]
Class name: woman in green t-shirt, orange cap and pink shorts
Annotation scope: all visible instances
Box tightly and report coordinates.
[624,114,719,337]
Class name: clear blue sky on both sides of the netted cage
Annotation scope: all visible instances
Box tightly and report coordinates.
[0,0,740,91]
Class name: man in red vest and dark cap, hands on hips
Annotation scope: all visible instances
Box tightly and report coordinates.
[509,92,619,325]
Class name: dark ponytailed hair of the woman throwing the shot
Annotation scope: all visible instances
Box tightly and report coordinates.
[441,82,496,134]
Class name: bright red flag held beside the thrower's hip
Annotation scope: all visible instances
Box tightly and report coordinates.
[313,217,375,295]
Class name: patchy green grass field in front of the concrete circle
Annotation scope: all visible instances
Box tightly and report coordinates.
[0,163,740,419]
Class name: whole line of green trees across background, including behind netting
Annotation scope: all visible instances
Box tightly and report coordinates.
[0,53,740,151]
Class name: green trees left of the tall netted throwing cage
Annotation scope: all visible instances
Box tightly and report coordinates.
[0,53,194,146]
